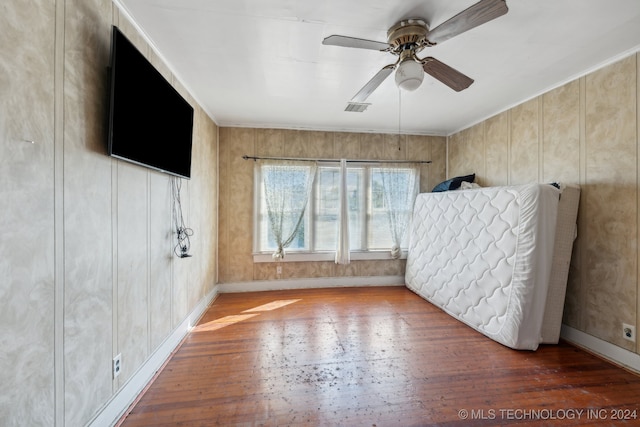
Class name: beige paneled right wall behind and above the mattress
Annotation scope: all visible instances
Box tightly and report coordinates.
[448,54,640,352]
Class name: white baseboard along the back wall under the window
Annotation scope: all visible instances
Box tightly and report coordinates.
[218,276,404,293]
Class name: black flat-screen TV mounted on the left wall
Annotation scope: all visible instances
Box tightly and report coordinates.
[108,26,193,178]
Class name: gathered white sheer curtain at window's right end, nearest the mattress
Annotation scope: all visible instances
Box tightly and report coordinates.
[380,164,420,259]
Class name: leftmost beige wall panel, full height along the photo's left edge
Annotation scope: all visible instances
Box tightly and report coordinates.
[0,0,56,425]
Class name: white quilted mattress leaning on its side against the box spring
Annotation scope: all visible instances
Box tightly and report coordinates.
[405,184,560,350]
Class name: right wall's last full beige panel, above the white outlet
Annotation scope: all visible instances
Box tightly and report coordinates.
[580,56,638,348]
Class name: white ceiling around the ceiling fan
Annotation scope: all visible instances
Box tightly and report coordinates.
[115,0,640,135]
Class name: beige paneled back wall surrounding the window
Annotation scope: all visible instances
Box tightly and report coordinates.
[219,128,446,283]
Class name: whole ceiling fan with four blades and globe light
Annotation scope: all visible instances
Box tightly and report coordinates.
[322,0,509,111]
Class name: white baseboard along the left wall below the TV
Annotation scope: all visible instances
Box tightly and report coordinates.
[87,286,219,427]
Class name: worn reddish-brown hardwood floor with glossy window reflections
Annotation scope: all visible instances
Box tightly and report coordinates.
[121,287,640,427]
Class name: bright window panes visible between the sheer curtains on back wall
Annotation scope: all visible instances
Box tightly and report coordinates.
[254,163,419,261]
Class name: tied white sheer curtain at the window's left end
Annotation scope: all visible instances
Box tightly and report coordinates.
[261,161,317,260]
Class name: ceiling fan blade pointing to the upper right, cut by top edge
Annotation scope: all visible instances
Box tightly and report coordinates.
[427,0,509,44]
